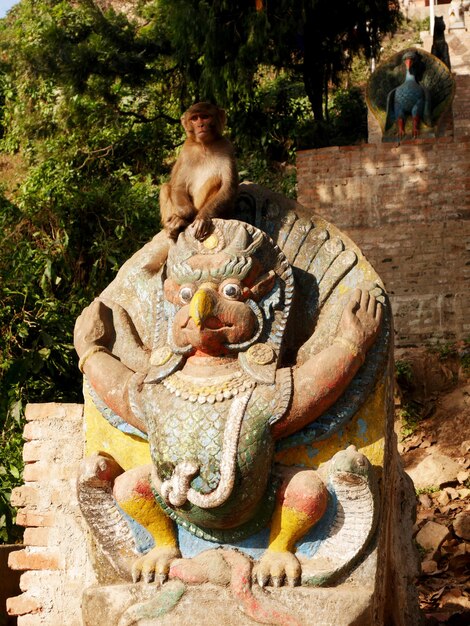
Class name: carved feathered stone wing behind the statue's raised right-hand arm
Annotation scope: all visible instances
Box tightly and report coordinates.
[238,184,392,449]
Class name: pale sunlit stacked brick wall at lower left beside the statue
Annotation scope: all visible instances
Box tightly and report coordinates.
[7,403,95,626]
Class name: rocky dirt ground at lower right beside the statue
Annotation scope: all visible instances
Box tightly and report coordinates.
[396,344,470,626]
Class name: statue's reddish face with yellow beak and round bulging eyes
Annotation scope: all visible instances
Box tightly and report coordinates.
[164,278,258,356]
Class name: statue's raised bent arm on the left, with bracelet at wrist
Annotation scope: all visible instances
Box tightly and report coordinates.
[74,300,146,432]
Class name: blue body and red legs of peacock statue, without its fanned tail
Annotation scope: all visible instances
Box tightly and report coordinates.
[385,50,431,139]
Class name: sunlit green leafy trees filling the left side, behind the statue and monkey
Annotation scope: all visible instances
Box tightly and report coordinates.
[0,0,174,540]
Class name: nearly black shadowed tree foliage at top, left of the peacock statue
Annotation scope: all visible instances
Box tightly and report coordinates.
[265,0,400,122]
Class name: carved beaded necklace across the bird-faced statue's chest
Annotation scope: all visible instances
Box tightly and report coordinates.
[162,371,256,404]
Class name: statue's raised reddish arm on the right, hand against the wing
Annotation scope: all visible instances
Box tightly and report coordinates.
[273,289,382,439]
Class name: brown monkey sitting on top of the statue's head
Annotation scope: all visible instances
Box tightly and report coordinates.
[160,102,238,241]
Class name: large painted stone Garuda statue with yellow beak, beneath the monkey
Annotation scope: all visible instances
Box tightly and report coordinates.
[75,185,391,623]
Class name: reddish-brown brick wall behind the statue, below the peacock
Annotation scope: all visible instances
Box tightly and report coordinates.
[297,135,470,346]
